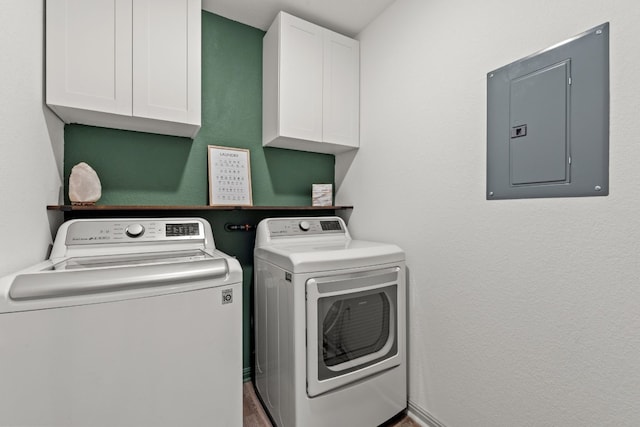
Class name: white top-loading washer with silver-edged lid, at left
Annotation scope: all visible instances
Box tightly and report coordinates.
[0,218,242,427]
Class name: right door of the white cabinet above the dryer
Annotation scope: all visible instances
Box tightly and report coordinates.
[322,30,360,148]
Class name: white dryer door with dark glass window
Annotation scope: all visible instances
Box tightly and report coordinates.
[306,267,400,397]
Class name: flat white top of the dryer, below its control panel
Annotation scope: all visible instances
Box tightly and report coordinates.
[254,240,405,273]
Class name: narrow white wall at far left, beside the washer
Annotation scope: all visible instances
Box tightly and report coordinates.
[0,0,63,276]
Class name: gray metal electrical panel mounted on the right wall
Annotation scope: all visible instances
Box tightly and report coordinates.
[487,23,609,200]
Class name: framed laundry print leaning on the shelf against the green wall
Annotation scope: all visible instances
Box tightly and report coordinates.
[208,145,253,206]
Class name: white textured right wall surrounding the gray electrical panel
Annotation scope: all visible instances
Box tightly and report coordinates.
[336,0,640,427]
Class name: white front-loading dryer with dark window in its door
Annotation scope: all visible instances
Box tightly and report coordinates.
[254,217,407,427]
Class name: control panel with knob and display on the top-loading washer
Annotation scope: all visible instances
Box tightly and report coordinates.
[65,219,205,246]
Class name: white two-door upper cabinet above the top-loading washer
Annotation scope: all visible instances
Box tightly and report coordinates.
[46,0,201,138]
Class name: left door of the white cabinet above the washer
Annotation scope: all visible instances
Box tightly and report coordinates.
[46,0,131,115]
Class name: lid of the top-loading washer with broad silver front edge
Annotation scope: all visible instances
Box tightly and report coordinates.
[0,251,242,315]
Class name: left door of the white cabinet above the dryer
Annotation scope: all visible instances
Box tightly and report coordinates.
[279,14,323,141]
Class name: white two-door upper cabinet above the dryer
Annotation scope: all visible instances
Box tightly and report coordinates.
[262,12,360,154]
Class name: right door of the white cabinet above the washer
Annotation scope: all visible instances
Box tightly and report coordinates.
[133,0,202,125]
